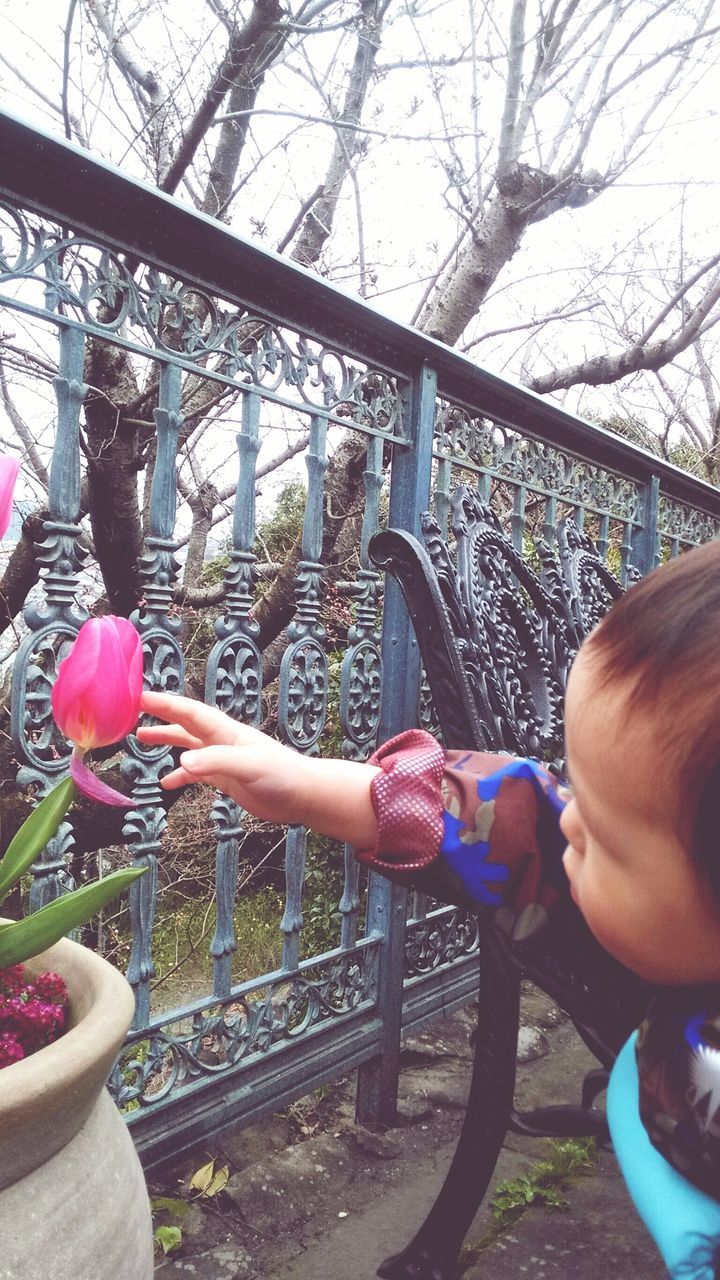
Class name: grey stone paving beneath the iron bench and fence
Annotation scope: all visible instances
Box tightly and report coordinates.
[151,992,665,1280]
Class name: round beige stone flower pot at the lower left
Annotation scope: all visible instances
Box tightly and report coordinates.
[0,941,152,1280]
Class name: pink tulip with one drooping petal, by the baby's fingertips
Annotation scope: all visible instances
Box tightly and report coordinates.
[51,614,142,805]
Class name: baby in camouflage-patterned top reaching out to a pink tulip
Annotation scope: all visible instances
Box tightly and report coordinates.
[138,543,720,1280]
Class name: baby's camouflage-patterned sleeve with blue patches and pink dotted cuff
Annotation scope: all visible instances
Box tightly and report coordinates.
[356,730,569,938]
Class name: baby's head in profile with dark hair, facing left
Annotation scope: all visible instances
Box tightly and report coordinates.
[562,543,720,983]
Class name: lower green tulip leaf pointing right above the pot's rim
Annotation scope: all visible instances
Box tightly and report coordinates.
[0,867,147,969]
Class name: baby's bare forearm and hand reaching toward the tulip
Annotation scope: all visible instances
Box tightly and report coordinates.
[137,692,379,849]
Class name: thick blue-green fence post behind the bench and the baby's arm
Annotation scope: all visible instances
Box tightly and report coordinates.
[356,365,437,1125]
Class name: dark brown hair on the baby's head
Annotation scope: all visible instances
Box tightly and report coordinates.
[579,541,720,900]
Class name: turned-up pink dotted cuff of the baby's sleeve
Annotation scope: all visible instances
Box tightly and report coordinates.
[356,728,446,872]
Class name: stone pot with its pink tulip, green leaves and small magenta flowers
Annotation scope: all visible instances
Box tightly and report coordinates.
[0,601,152,1280]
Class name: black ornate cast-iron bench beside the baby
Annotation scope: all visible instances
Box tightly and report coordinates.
[370,486,652,1280]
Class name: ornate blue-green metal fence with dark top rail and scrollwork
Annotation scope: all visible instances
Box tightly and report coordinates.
[0,116,720,1165]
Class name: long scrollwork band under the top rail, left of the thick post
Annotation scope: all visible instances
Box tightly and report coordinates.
[0,202,404,438]
